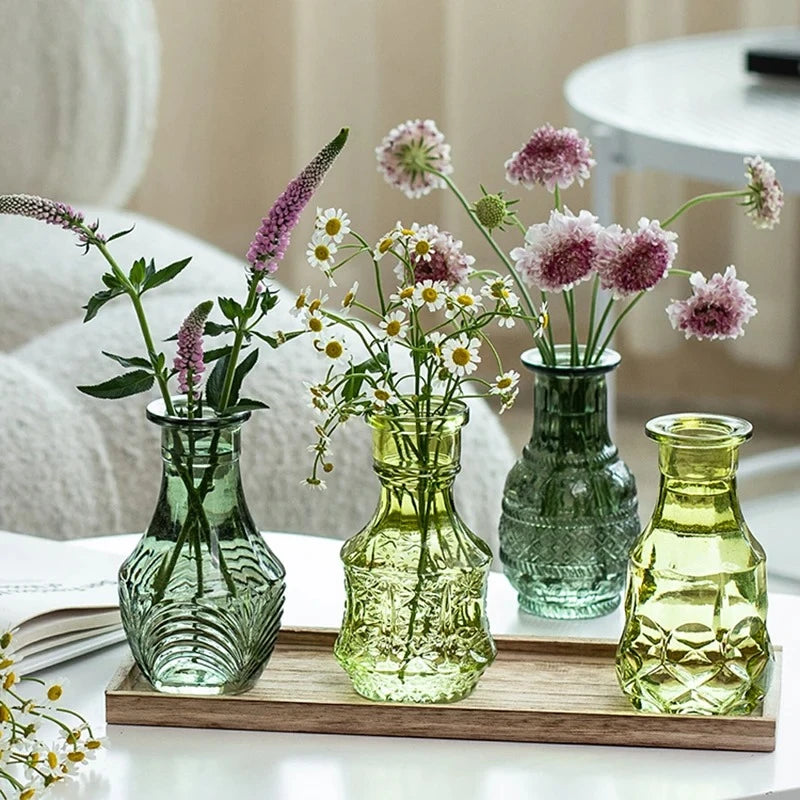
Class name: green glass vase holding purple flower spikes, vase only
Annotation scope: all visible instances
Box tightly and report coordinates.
[119,399,285,695]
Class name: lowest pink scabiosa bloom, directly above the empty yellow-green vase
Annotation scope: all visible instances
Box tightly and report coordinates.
[667,265,756,340]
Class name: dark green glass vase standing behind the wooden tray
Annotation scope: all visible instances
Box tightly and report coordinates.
[500,345,640,619]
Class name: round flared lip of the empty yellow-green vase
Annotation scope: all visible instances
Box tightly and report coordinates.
[645,411,753,449]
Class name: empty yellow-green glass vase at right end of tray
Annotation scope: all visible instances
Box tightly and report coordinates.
[617,414,773,714]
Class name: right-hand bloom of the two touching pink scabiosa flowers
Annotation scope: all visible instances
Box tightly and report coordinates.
[597,217,678,298]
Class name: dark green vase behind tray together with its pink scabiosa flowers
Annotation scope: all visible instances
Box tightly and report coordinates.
[376,120,783,618]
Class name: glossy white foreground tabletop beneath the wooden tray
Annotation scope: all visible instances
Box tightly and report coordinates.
[39,534,800,800]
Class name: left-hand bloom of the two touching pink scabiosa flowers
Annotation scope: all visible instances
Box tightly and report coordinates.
[511,208,602,292]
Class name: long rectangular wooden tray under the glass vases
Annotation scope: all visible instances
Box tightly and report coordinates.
[106,628,780,751]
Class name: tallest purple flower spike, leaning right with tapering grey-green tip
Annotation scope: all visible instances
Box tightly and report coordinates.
[247,128,349,273]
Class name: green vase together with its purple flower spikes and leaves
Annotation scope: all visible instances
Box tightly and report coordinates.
[0,129,348,694]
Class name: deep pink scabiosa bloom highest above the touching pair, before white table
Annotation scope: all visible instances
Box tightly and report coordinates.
[505,124,597,192]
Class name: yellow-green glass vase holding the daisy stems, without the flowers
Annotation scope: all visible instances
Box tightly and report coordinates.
[334,402,496,703]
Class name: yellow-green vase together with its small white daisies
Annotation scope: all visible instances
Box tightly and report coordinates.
[294,209,545,703]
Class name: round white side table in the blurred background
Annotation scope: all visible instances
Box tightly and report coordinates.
[564,28,800,224]
